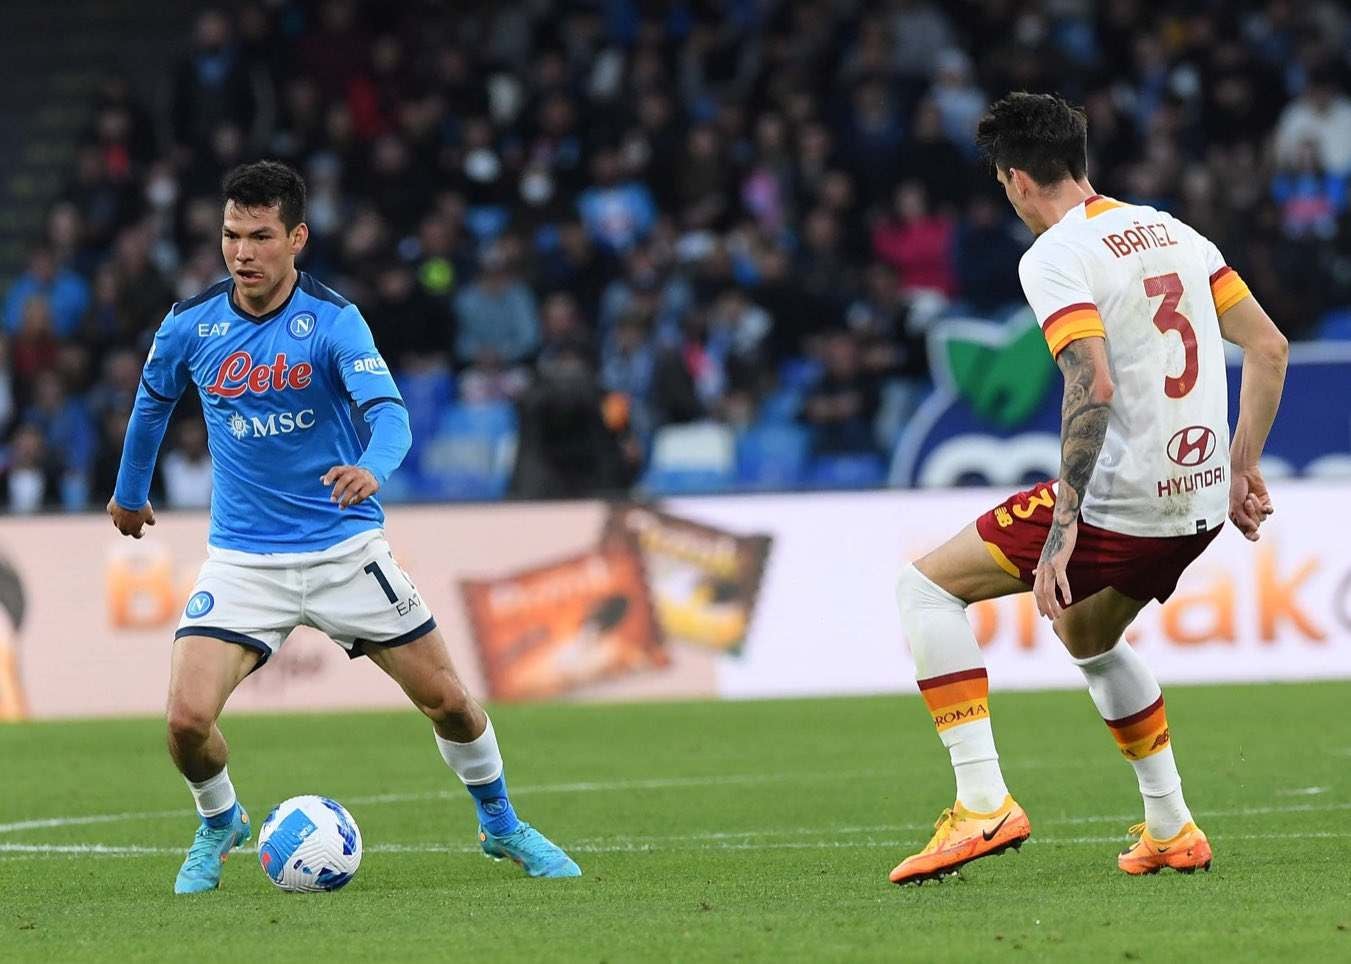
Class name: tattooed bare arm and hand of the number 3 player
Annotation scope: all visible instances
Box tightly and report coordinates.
[1032,338,1113,620]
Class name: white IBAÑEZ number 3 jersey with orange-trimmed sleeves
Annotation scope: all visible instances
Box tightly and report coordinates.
[1019,196,1248,536]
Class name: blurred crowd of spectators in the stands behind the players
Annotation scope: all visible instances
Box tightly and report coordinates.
[0,0,1351,512]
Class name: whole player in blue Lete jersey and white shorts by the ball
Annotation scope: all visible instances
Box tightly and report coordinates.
[108,161,581,894]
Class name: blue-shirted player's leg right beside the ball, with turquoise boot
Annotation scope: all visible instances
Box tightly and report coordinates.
[166,636,259,894]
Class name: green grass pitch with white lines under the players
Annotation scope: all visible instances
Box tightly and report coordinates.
[0,685,1351,961]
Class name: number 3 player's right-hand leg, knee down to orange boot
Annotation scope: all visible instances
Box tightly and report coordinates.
[1054,587,1210,874]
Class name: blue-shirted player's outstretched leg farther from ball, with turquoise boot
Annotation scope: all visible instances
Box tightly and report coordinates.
[362,629,581,878]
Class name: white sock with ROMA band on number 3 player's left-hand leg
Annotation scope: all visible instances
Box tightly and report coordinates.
[896,566,1009,813]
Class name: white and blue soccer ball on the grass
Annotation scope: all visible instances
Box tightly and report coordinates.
[258,797,361,892]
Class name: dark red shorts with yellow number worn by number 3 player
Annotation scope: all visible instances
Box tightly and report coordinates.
[975,482,1220,602]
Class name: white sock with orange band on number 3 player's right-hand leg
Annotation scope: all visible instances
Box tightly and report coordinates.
[1074,640,1192,840]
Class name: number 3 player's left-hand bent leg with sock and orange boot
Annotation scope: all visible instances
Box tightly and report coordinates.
[892,525,1031,883]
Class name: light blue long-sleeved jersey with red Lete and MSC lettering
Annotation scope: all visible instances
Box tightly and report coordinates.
[115,271,411,552]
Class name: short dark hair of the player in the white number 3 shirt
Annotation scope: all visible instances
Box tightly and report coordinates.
[975,90,1089,186]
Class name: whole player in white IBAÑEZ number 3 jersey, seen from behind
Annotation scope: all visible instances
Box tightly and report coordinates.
[890,93,1288,883]
